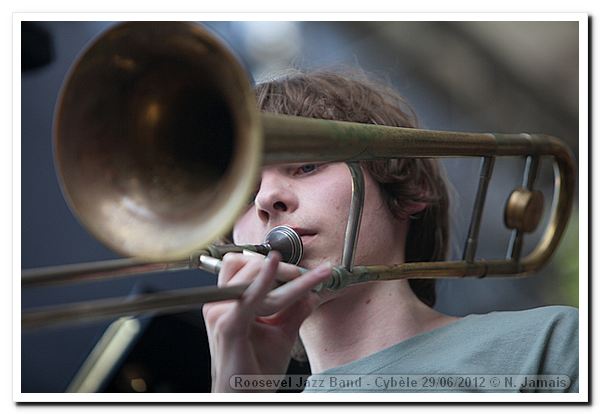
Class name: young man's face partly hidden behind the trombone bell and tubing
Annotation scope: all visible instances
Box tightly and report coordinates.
[233,163,405,269]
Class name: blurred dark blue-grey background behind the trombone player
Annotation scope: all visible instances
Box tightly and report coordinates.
[20,22,587,392]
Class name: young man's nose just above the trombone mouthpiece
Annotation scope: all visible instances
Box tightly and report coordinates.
[254,169,298,223]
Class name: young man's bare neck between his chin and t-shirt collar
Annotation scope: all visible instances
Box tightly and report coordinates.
[300,280,457,374]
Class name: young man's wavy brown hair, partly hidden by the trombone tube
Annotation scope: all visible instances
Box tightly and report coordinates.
[255,70,449,307]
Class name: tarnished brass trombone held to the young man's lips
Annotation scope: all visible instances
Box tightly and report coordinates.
[22,22,575,327]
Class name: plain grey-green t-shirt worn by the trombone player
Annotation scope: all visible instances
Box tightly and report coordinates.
[304,306,579,392]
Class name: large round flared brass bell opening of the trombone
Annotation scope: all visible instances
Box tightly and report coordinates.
[54,22,262,259]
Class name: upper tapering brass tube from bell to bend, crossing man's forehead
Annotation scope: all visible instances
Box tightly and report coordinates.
[261,113,554,165]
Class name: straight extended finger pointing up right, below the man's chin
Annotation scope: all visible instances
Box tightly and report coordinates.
[256,264,331,316]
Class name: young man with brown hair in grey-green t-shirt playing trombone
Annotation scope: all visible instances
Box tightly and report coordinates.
[204,72,578,392]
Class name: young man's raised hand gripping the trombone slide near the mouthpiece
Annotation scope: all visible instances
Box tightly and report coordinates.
[202,252,331,392]
